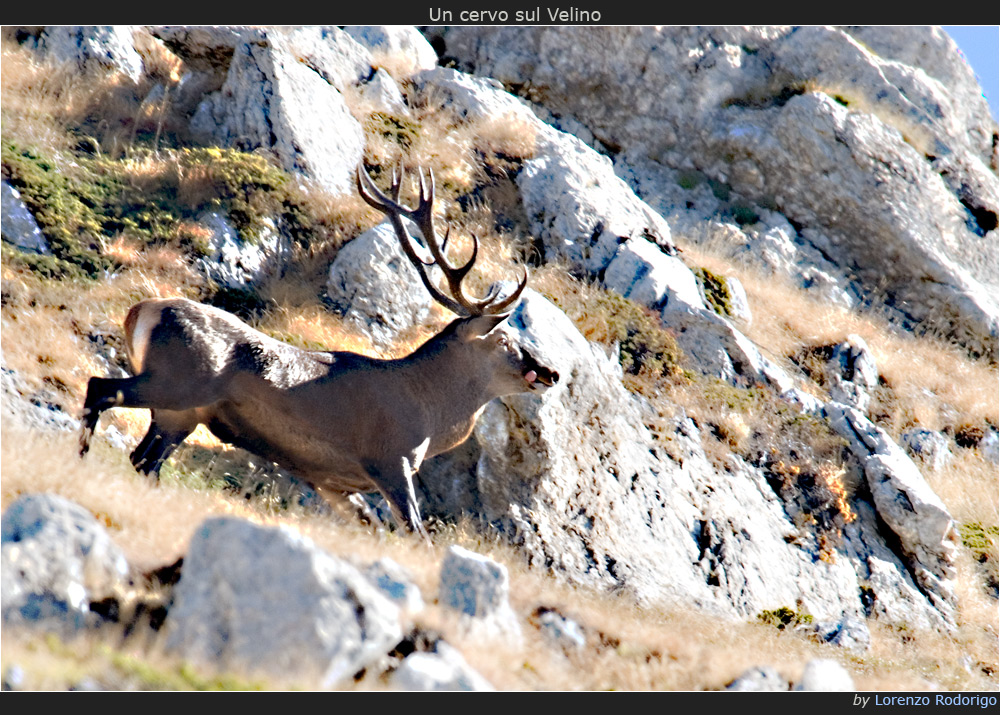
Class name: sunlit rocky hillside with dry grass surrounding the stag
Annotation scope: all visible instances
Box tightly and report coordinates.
[2,26,1000,690]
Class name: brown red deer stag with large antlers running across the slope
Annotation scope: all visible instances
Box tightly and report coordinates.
[80,166,559,537]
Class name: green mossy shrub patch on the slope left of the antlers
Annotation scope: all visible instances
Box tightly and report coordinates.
[3,141,314,278]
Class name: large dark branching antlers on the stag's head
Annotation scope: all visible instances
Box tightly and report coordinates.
[357,164,528,316]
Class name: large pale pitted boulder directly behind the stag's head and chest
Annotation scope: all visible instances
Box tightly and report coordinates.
[420,289,944,625]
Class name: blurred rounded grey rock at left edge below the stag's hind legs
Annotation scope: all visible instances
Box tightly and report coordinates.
[0,494,129,630]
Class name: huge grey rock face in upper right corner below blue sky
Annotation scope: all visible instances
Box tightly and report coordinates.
[442,27,998,359]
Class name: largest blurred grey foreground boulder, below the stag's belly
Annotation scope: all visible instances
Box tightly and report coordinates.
[165,518,402,686]
